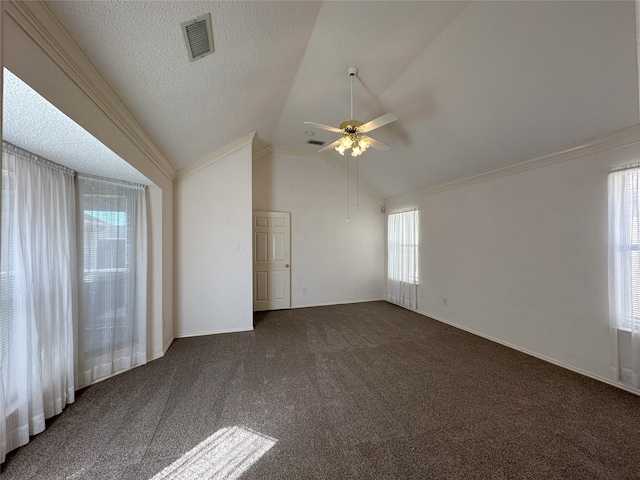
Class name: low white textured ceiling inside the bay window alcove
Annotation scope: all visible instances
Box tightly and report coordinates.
[2,69,151,185]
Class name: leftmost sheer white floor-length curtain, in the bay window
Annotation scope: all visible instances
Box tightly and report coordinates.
[0,143,76,461]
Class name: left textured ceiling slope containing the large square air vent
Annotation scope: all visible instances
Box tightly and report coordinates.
[49,0,321,170]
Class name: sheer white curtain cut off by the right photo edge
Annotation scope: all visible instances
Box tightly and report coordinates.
[609,165,640,388]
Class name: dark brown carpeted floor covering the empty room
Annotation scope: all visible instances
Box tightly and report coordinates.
[2,302,640,480]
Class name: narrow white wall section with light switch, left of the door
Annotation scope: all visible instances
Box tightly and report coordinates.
[174,143,253,337]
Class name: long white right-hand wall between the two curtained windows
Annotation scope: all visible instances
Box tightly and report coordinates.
[388,129,640,386]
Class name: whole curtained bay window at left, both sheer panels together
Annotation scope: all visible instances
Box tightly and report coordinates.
[0,142,147,462]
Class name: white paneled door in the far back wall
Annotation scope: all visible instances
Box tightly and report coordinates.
[253,212,291,311]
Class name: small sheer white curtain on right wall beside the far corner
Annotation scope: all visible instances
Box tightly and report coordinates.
[387,210,419,309]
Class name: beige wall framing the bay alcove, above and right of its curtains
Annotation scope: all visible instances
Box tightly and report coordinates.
[1,2,173,359]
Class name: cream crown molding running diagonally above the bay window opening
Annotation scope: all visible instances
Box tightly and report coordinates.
[3,0,175,181]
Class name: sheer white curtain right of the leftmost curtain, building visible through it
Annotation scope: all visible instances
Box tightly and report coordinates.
[77,175,147,386]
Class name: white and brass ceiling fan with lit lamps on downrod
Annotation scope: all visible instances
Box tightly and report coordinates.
[304,67,398,157]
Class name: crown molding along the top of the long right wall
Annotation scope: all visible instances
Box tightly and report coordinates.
[384,124,640,205]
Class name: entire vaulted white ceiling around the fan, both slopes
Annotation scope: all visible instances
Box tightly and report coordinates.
[49,0,639,198]
